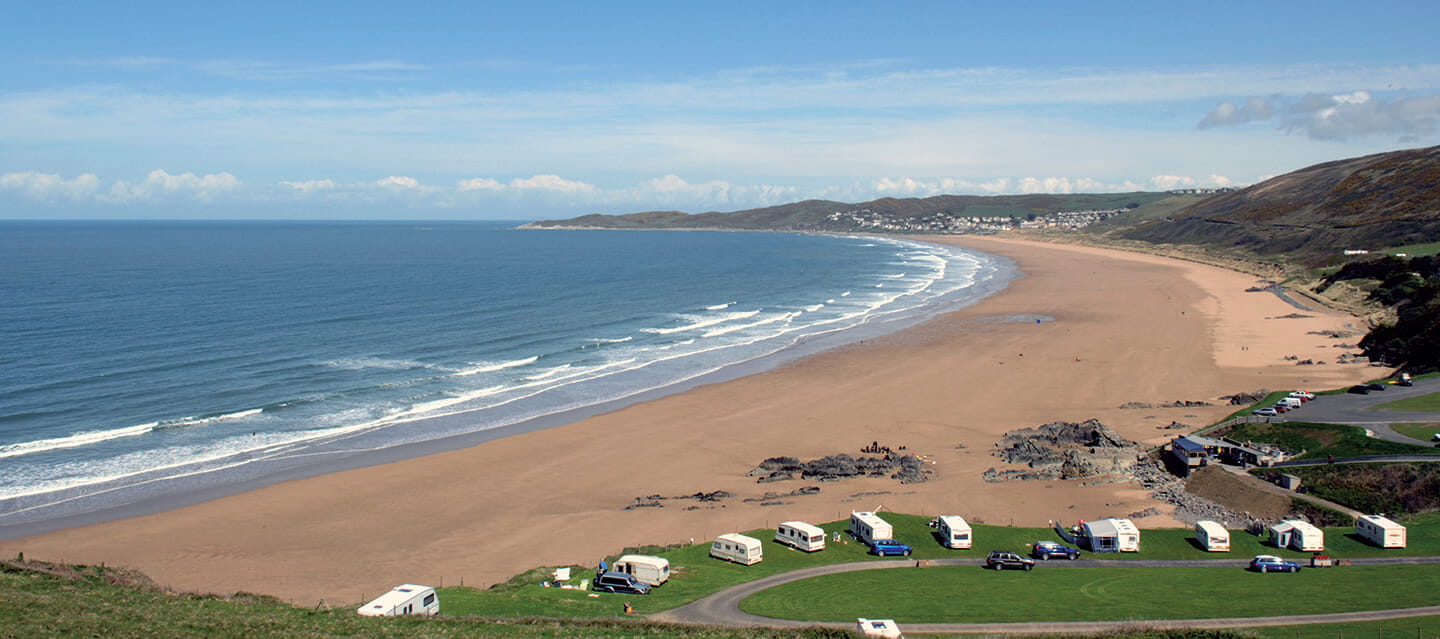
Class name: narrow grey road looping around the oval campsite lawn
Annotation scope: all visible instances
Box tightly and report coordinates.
[648,557,1440,633]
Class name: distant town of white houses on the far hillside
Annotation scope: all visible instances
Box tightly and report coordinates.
[825,187,1237,233]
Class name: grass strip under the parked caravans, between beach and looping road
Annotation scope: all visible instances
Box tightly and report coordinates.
[439,512,1440,617]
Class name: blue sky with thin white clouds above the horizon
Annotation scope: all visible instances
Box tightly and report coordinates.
[0,0,1440,220]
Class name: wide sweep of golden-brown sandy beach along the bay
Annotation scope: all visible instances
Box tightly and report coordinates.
[0,237,1381,604]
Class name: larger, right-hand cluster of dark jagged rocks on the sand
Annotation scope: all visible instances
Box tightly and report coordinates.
[984,419,1143,482]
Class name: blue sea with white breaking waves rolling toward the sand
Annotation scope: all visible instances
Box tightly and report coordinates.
[0,222,1014,537]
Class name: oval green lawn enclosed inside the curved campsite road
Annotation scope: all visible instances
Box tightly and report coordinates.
[740,566,1440,623]
